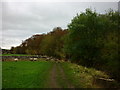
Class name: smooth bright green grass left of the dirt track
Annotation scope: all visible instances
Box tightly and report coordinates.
[2,61,53,88]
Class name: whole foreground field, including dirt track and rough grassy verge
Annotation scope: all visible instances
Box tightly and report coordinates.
[2,61,115,88]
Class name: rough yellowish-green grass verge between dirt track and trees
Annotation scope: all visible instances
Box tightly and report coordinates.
[61,62,109,88]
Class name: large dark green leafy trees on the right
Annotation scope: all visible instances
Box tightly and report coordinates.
[64,9,120,80]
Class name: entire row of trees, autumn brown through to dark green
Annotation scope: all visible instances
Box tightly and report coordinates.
[11,9,120,80]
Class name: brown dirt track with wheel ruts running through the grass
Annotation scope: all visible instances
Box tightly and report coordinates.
[49,63,74,88]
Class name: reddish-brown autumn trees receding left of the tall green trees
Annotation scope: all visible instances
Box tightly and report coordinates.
[11,27,68,59]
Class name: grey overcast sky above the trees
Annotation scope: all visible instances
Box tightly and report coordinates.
[0,2,118,49]
